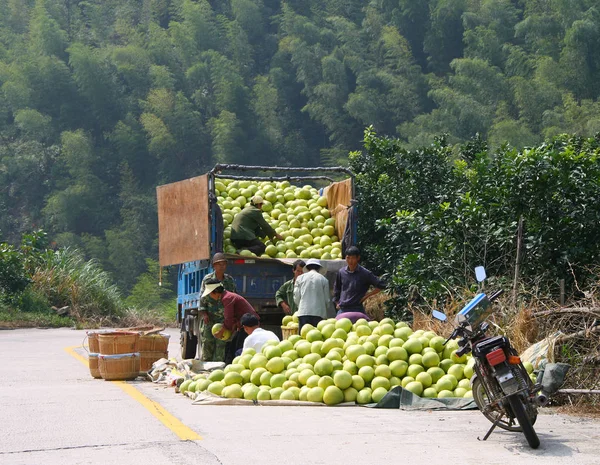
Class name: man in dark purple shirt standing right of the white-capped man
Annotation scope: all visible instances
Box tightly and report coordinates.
[333,246,385,315]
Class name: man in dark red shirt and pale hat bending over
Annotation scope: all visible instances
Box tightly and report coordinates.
[202,278,260,365]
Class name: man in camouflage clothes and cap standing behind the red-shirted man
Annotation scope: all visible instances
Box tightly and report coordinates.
[198,252,237,362]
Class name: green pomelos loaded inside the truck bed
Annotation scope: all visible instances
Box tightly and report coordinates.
[215,178,342,260]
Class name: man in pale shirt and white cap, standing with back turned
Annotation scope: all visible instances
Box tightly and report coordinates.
[294,258,331,331]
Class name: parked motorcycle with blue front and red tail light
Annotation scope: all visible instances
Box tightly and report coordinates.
[433,267,548,449]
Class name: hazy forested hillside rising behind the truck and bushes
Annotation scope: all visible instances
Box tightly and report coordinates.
[0,0,600,291]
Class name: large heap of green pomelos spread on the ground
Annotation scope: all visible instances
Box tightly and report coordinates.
[180,318,474,405]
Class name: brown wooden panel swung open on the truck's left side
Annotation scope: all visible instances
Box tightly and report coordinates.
[156,175,210,266]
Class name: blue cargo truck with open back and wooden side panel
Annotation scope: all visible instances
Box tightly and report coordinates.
[156,164,357,359]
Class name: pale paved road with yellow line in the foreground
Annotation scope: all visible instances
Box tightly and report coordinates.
[0,329,600,465]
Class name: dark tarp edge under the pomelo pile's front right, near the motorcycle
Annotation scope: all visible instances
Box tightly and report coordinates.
[367,386,477,410]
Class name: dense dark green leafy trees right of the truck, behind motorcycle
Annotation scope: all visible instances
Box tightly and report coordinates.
[351,130,600,304]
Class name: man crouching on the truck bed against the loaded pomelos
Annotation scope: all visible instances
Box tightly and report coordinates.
[231,195,283,256]
